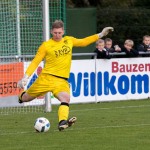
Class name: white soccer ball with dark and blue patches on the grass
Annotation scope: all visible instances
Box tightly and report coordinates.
[34,117,50,132]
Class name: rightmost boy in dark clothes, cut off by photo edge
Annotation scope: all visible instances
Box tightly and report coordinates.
[137,35,150,57]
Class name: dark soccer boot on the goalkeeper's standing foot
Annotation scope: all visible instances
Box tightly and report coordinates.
[58,117,77,131]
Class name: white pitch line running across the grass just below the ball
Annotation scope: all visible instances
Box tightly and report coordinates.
[0,124,150,136]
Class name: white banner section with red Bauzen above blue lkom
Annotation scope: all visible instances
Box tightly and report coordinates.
[96,58,150,101]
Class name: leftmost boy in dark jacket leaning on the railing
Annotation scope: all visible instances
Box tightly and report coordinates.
[92,39,110,59]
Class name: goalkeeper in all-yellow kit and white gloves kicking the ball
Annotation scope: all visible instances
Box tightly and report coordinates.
[18,20,113,131]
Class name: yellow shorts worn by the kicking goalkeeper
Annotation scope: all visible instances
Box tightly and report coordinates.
[26,73,70,97]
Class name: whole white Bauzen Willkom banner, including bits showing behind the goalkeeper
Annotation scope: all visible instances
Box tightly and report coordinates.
[24,58,150,104]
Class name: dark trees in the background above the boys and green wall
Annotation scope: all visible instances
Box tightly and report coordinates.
[67,0,150,45]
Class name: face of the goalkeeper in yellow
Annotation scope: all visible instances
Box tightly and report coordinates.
[51,28,64,42]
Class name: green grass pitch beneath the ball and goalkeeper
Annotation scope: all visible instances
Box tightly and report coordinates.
[0,100,150,150]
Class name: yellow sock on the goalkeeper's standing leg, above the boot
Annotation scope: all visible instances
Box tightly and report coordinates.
[58,104,69,122]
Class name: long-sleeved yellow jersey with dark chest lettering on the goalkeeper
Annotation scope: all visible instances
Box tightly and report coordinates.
[26,34,99,78]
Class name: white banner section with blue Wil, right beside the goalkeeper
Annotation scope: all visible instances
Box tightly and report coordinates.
[68,59,96,103]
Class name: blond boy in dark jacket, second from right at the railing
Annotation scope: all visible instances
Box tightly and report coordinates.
[122,39,138,57]
